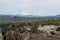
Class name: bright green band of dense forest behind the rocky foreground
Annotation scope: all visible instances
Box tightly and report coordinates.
[0,20,60,27]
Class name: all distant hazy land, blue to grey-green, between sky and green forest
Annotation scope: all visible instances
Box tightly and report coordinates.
[0,14,60,23]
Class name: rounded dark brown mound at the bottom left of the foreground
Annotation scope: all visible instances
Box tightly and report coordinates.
[6,31,21,40]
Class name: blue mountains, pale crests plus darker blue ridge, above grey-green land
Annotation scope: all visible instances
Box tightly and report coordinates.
[0,14,60,19]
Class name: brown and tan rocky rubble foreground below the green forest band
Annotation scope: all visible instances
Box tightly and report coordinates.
[0,25,60,40]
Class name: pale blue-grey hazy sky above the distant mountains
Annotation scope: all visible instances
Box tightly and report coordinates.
[0,0,60,16]
